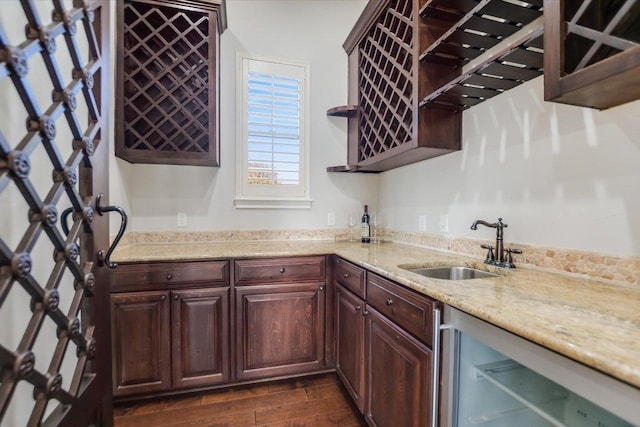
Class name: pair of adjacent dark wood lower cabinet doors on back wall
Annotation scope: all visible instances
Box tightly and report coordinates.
[111,287,231,397]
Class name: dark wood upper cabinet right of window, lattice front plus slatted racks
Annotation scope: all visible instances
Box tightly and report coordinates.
[327,0,543,172]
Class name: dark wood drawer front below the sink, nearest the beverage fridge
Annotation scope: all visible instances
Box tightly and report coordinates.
[367,273,437,345]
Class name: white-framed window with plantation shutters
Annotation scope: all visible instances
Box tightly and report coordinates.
[235,54,311,208]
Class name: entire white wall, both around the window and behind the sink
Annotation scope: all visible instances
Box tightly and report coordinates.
[111,0,640,255]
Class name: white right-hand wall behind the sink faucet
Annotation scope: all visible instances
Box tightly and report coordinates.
[379,77,640,255]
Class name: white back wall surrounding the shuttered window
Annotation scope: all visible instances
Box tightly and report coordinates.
[111,0,377,232]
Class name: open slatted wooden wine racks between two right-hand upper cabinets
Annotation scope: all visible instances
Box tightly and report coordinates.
[420,0,543,111]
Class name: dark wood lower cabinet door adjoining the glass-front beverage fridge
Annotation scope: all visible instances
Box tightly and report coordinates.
[365,307,432,427]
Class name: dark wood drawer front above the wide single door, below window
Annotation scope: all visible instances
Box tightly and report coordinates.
[235,256,325,285]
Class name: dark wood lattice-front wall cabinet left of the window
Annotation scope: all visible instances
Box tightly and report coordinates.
[116,0,227,166]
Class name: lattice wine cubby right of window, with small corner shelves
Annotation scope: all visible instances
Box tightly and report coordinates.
[328,0,461,172]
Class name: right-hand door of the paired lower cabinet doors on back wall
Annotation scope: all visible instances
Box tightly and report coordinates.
[171,287,230,388]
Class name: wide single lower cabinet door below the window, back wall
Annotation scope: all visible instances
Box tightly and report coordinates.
[235,282,325,380]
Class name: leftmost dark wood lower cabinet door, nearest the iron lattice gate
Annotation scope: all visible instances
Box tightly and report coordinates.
[111,292,171,396]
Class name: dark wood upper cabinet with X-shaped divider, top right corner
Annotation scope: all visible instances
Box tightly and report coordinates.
[544,0,640,109]
